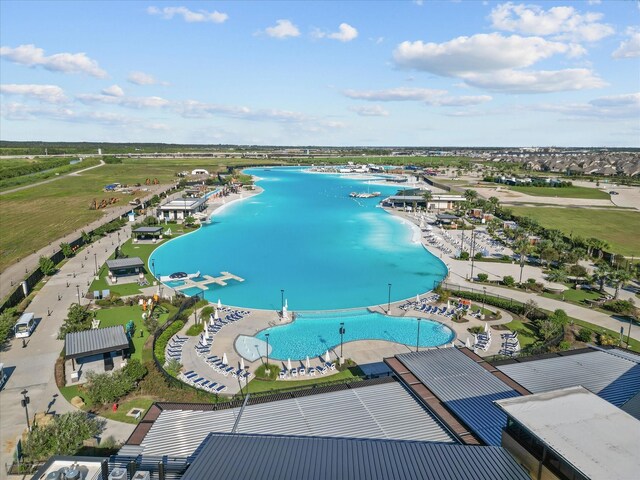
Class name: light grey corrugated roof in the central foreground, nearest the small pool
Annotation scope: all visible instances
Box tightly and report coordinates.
[141,382,455,456]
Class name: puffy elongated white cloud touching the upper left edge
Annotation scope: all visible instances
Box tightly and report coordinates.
[0,44,107,78]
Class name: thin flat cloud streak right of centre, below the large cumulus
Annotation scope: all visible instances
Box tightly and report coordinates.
[344,87,491,107]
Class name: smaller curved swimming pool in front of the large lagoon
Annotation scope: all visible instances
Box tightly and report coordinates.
[256,310,455,360]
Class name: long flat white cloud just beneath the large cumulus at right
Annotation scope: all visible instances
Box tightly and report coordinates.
[464,68,607,93]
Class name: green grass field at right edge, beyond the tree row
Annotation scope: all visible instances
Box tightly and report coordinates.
[509,206,640,256]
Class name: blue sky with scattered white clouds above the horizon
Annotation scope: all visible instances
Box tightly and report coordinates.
[0,0,640,147]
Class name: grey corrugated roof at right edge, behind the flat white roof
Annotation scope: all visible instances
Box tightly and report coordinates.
[497,350,640,407]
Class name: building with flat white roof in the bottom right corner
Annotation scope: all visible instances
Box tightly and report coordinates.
[496,387,640,480]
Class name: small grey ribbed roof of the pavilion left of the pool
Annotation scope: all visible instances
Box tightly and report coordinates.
[64,325,129,358]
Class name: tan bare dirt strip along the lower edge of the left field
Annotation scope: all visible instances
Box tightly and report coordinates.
[0,185,173,299]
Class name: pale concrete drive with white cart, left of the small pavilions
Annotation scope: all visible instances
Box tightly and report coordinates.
[0,226,139,471]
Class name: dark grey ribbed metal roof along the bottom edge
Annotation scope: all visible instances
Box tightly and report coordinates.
[182,434,529,480]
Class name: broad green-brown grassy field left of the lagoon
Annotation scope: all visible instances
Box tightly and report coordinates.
[0,159,265,270]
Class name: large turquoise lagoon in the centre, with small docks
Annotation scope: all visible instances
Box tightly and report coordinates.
[150,168,446,311]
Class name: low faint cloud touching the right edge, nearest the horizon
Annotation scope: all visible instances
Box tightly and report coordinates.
[533,93,640,119]
